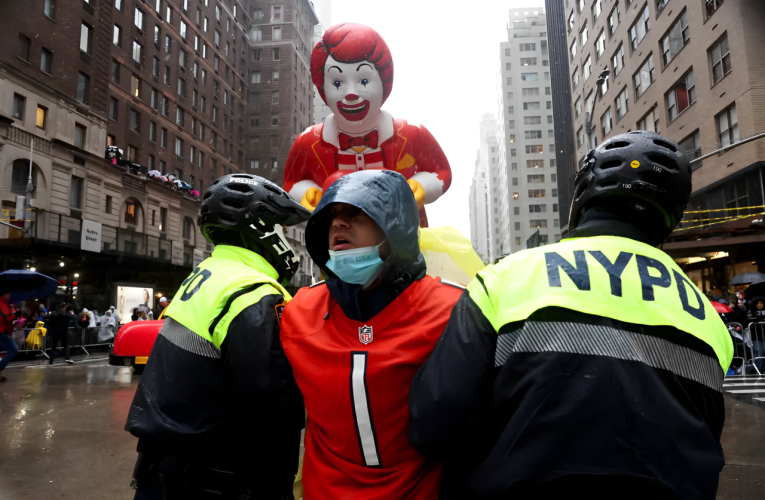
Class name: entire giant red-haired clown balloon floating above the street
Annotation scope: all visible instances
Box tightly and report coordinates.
[284,23,452,227]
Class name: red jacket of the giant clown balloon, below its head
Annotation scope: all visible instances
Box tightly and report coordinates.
[283,111,452,225]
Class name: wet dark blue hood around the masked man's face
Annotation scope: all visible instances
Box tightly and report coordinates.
[305,170,426,321]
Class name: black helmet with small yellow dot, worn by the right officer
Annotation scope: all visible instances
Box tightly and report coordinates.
[569,130,691,239]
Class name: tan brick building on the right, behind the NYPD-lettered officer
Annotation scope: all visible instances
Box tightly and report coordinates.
[547,0,765,289]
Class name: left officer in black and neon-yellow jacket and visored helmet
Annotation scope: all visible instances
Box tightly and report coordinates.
[125,174,311,500]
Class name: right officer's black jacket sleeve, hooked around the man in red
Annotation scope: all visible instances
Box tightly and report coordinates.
[409,290,497,455]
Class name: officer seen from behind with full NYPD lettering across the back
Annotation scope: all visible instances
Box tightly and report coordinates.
[409,131,732,500]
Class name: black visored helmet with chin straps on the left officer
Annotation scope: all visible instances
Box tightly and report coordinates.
[197,174,311,282]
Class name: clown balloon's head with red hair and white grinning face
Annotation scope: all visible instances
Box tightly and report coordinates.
[311,23,393,133]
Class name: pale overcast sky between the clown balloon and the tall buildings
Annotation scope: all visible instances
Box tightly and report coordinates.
[314,0,544,237]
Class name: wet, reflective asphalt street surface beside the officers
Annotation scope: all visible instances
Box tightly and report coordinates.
[0,353,765,500]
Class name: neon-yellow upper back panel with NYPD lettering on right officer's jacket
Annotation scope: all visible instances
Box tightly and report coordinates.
[468,236,733,370]
